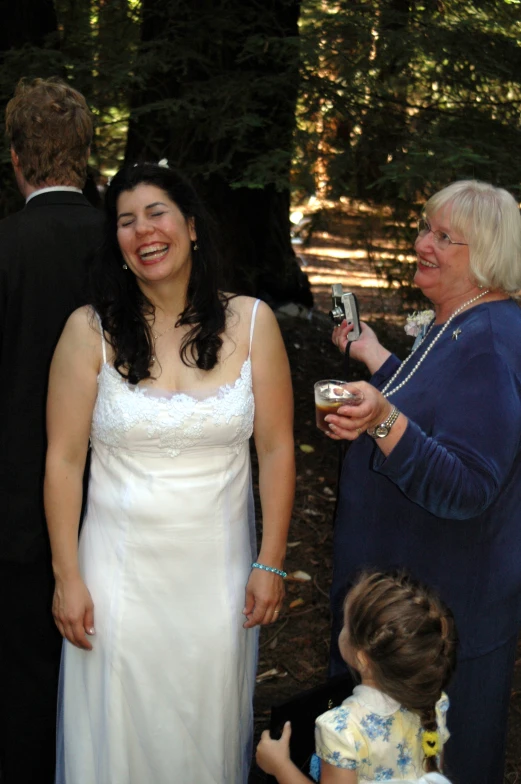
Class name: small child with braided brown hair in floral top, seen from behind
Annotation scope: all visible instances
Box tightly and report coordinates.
[257,572,457,784]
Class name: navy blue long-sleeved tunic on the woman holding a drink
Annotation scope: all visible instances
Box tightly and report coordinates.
[331,299,521,776]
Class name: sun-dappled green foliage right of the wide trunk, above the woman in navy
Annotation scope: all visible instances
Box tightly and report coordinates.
[294,0,521,294]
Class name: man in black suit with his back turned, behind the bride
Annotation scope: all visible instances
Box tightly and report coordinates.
[0,79,103,784]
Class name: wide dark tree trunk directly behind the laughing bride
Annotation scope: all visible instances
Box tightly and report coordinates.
[126,0,312,304]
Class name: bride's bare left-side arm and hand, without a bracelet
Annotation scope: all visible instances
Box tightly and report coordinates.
[44,308,101,649]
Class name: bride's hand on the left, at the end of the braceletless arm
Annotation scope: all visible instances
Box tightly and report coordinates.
[52,576,94,651]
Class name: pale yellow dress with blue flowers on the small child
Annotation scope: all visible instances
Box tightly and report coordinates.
[315,686,449,784]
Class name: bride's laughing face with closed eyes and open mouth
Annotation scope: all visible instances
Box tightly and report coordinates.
[117,183,196,285]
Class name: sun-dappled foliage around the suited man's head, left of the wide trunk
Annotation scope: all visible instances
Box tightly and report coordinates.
[0,0,140,214]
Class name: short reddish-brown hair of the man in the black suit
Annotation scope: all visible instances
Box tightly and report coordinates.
[5,79,93,188]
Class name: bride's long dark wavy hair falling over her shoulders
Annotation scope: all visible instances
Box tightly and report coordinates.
[90,163,228,384]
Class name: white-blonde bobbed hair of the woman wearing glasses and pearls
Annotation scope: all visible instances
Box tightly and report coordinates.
[424,180,521,294]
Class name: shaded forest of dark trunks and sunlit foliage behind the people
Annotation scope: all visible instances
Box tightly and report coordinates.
[0,0,521,306]
